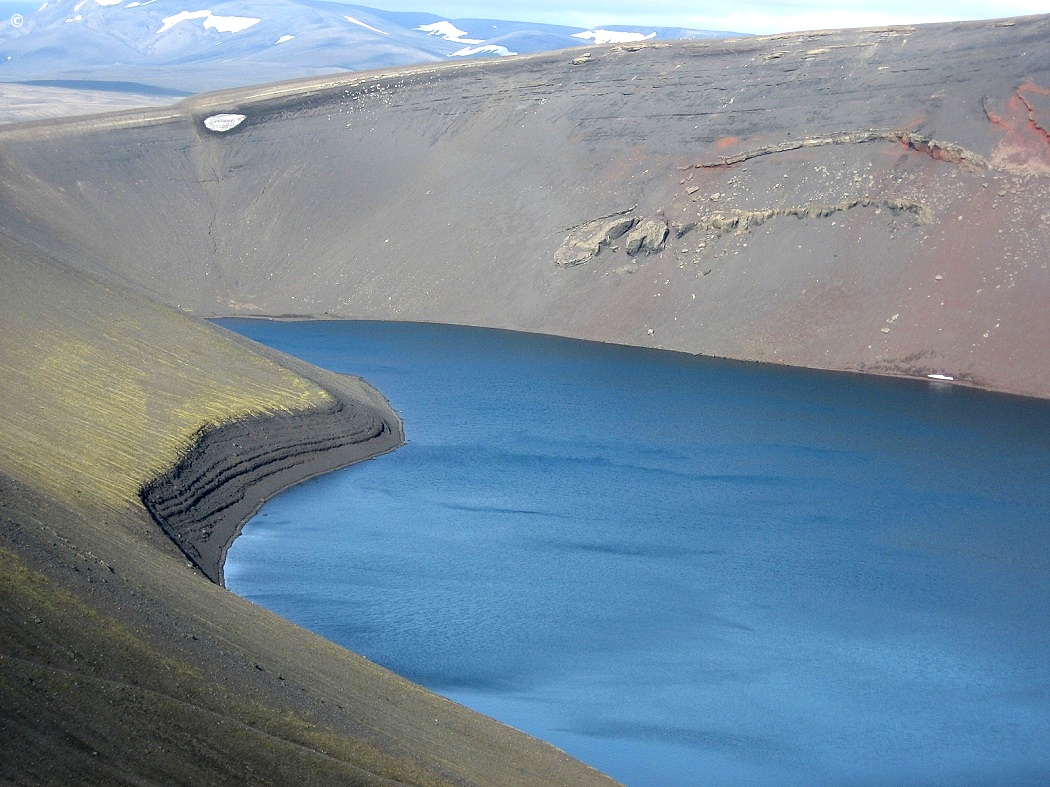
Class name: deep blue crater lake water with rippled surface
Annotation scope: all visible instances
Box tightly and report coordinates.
[222,320,1050,785]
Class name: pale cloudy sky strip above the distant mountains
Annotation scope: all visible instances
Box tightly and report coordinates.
[357,0,1050,34]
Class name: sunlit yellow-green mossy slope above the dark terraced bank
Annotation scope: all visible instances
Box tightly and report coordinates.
[0,262,332,514]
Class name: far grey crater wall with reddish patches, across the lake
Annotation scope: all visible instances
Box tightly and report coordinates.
[0,17,1050,396]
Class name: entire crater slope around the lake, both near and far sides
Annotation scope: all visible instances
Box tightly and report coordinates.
[0,16,1050,784]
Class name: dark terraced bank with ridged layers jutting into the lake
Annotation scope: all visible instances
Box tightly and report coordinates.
[140,369,404,587]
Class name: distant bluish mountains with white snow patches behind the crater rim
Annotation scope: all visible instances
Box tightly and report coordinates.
[0,0,735,94]
